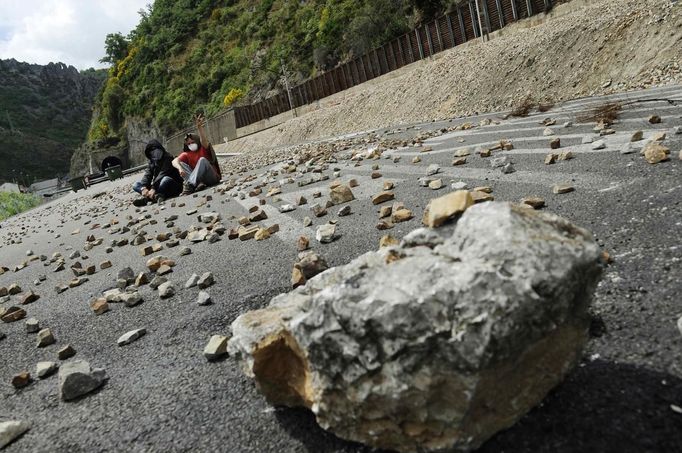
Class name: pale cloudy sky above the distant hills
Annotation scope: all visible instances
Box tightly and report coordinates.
[0,0,153,69]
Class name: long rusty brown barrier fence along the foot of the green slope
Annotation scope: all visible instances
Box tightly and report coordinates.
[164,0,552,149]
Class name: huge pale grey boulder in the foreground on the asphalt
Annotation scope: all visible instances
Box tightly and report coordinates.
[229,203,601,452]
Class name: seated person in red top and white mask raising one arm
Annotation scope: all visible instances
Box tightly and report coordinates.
[173,115,221,195]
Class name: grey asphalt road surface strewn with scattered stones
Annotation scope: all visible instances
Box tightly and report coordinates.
[0,87,682,452]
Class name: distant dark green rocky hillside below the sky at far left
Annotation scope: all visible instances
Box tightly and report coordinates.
[0,59,106,184]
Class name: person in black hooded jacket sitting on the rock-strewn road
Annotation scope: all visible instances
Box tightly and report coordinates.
[133,140,183,206]
